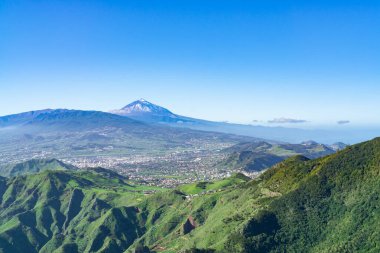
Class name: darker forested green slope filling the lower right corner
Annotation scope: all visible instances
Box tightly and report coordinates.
[225,139,380,252]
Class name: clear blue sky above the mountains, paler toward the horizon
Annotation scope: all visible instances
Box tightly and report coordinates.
[0,0,380,126]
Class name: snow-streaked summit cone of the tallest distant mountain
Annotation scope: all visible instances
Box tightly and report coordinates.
[112,98,175,116]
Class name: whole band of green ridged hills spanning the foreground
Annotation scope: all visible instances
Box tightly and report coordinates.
[0,139,380,253]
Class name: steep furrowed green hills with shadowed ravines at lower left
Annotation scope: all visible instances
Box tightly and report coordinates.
[0,169,161,252]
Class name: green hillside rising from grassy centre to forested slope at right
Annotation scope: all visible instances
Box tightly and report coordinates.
[133,139,380,252]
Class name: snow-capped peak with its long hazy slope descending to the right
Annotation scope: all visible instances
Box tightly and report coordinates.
[111,99,351,143]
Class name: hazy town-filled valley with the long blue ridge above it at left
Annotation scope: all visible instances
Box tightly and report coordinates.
[0,110,248,187]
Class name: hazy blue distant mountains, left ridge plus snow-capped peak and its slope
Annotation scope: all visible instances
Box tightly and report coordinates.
[0,99,360,143]
